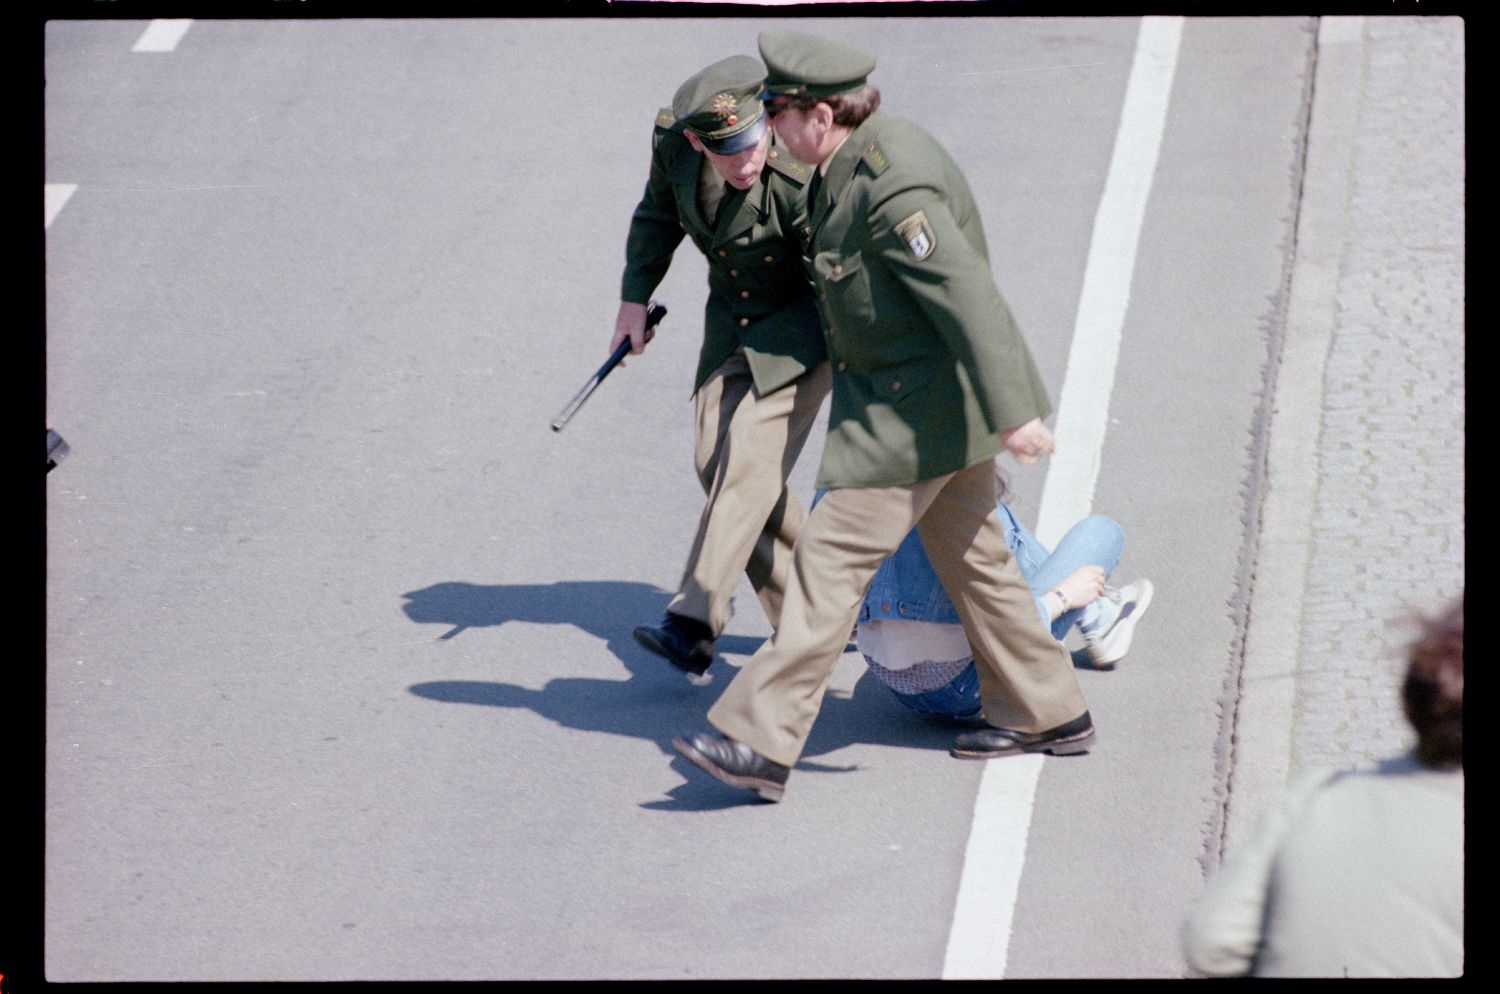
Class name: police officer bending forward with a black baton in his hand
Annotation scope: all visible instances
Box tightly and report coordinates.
[609,55,849,676]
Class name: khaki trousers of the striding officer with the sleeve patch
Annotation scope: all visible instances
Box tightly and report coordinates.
[708,459,1088,766]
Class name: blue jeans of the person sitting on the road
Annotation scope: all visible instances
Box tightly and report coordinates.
[891,502,1125,718]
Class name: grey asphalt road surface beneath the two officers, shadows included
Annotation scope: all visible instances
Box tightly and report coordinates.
[45,16,1416,981]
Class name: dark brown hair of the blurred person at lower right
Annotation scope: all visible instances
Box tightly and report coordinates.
[1401,595,1464,768]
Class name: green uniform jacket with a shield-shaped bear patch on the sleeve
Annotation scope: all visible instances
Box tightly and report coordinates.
[803,112,1052,487]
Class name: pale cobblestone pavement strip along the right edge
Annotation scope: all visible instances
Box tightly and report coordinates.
[1290,16,1464,774]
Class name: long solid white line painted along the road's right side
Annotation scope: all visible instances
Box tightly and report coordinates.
[942,16,1182,981]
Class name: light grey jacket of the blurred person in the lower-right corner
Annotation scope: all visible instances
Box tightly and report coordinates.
[1185,754,1464,978]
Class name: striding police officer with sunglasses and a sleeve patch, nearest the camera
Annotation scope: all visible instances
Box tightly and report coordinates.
[674,31,1094,801]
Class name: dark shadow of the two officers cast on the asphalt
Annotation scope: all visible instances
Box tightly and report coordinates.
[404,580,957,811]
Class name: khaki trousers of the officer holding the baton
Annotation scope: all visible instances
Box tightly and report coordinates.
[666,349,849,639]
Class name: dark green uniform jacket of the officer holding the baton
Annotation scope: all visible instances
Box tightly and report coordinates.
[620,111,827,396]
